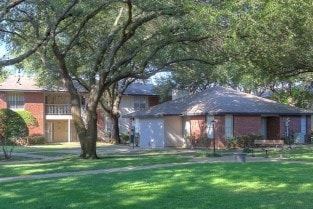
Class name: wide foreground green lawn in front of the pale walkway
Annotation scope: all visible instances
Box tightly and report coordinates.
[0,161,313,209]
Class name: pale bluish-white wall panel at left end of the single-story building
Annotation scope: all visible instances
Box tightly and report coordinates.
[139,118,165,148]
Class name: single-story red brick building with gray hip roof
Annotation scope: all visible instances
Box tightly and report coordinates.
[125,87,313,148]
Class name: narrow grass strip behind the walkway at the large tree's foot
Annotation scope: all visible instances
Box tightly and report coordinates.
[0,155,190,177]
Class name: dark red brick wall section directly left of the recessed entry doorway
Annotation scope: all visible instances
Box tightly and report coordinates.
[234,115,261,136]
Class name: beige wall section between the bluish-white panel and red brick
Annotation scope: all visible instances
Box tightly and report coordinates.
[164,116,186,147]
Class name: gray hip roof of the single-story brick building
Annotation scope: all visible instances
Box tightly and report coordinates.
[124,87,313,118]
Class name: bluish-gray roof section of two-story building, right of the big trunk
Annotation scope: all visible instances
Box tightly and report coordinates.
[123,83,158,96]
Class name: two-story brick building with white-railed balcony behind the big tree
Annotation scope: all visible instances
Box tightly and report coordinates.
[0,76,158,142]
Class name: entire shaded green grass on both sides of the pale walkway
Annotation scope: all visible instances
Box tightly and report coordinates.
[0,146,313,209]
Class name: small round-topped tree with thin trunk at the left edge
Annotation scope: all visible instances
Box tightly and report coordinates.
[0,109,28,159]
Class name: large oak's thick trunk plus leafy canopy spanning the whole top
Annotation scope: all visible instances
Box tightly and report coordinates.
[0,0,313,158]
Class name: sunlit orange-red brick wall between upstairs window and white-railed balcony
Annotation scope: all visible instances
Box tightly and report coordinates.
[24,92,45,135]
